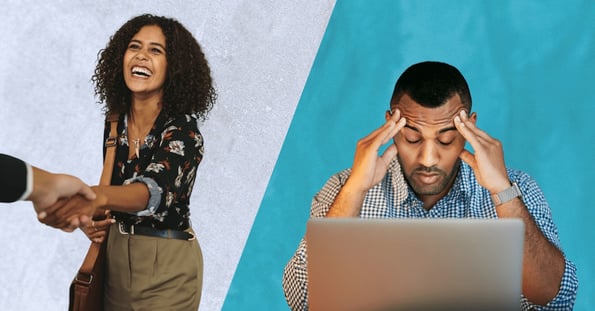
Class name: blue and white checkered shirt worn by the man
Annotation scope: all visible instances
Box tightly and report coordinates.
[283,158,578,311]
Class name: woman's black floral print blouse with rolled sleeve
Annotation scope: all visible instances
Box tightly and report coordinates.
[103,113,204,230]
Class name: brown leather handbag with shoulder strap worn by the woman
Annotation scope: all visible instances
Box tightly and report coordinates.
[68,114,118,311]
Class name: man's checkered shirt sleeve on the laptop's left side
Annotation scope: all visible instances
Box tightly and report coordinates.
[282,170,349,311]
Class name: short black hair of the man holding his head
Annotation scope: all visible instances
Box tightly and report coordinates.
[390,61,471,112]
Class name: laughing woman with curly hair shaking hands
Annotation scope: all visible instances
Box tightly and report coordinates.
[53,15,216,310]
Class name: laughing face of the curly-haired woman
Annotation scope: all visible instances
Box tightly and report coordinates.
[123,25,167,100]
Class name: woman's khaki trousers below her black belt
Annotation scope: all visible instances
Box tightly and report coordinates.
[104,223,203,311]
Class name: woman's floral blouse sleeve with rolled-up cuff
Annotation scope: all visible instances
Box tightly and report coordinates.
[126,115,204,216]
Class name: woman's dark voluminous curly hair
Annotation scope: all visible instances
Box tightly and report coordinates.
[91,14,217,120]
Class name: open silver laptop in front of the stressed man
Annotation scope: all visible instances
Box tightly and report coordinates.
[306,218,524,311]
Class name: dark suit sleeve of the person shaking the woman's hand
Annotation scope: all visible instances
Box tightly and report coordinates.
[0,153,27,202]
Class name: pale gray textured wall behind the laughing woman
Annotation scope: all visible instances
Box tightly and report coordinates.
[0,0,334,310]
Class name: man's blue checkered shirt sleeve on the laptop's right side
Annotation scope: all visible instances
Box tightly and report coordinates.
[511,171,578,310]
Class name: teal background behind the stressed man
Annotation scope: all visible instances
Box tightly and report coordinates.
[223,0,595,310]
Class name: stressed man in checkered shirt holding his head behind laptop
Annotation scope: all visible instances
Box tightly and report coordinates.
[283,62,578,310]
